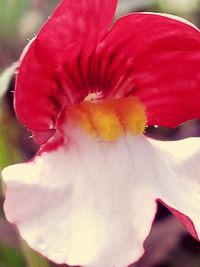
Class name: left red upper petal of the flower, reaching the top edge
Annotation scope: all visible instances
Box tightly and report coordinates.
[15,0,117,137]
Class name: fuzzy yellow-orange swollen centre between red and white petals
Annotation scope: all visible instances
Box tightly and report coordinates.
[71,97,146,141]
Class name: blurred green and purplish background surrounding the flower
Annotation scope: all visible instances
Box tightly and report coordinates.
[0,0,200,267]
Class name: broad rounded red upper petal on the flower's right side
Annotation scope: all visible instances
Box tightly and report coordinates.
[103,13,200,127]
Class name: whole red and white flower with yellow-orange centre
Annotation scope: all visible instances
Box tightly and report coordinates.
[3,0,200,267]
